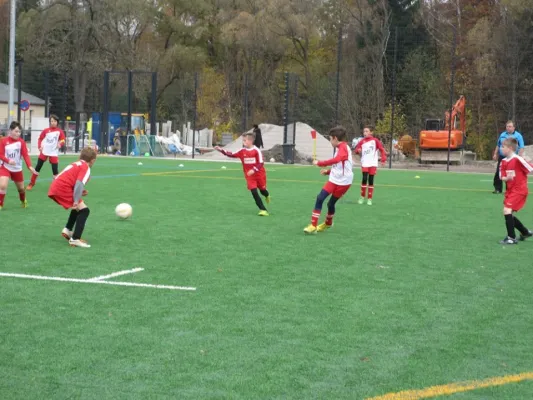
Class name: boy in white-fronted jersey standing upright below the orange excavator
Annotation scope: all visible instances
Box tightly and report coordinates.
[355,126,387,206]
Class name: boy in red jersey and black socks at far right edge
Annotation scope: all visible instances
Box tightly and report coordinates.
[500,138,533,244]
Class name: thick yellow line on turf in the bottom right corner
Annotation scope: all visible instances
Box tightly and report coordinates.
[367,372,533,400]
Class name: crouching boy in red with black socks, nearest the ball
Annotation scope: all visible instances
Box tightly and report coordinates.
[48,147,96,248]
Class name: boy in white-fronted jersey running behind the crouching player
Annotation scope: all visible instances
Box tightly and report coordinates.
[26,114,65,190]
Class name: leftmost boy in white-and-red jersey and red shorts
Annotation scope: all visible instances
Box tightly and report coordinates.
[0,121,37,210]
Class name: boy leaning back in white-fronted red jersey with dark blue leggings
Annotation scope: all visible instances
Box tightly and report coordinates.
[304,126,353,234]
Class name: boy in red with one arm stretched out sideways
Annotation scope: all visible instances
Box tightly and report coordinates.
[215,133,270,217]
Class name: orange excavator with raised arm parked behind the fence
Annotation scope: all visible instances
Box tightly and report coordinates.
[419,96,466,162]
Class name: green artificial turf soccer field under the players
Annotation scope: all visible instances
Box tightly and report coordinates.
[0,157,533,400]
